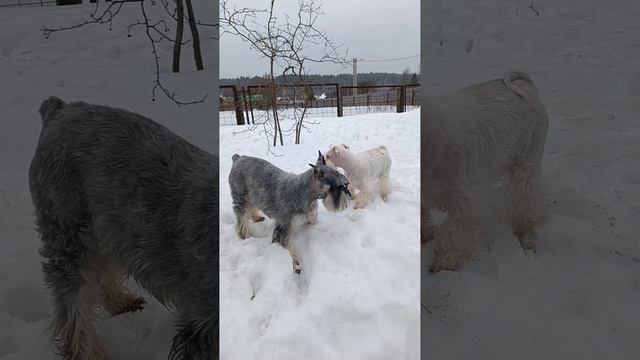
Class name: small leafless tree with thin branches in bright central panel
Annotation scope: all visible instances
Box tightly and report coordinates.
[220,0,346,146]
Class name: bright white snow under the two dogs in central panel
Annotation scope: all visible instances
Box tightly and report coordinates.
[220,110,420,360]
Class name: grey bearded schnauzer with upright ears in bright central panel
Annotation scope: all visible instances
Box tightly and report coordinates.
[229,151,351,273]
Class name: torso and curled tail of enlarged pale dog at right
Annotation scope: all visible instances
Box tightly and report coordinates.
[421,70,549,170]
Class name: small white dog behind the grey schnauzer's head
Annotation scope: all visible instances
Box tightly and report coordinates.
[326,144,391,209]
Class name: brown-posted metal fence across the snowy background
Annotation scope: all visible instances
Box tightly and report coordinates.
[219,84,420,125]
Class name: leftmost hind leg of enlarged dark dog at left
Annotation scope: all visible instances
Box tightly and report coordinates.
[40,225,106,360]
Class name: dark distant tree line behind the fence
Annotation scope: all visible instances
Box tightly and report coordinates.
[220,72,418,86]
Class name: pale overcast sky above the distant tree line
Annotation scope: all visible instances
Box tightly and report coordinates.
[220,0,420,78]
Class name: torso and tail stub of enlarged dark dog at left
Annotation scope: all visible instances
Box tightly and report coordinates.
[29,97,218,295]
